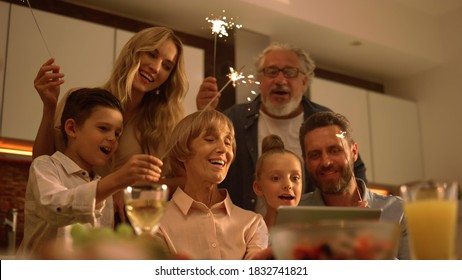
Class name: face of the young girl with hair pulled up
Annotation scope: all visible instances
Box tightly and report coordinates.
[253,152,303,209]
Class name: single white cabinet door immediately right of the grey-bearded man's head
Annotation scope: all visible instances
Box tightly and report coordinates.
[311,78,375,182]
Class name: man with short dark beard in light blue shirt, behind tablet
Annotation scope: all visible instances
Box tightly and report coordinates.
[299,112,410,259]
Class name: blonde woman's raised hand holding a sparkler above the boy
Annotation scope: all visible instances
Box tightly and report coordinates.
[34,58,64,107]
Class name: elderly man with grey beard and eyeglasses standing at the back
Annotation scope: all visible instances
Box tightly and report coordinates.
[196,43,366,214]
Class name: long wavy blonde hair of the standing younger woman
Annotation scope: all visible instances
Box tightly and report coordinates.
[104,27,188,172]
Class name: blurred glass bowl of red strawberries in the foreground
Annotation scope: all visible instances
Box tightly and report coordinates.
[270,220,401,260]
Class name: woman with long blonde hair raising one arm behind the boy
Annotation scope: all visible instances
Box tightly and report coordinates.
[33,27,188,228]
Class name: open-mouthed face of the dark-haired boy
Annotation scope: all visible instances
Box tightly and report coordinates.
[65,106,123,172]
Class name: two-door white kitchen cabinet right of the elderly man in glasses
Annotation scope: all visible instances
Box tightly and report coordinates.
[310,78,423,185]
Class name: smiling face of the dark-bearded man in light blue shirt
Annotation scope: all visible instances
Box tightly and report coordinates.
[303,125,358,194]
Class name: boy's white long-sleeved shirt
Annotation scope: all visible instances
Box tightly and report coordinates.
[18,152,105,256]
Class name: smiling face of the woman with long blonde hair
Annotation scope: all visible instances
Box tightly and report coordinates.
[132,39,178,94]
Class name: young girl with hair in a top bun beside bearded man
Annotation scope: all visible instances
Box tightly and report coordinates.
[253,134,303,228]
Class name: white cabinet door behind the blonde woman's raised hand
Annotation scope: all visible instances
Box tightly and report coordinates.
[1,5,114,140]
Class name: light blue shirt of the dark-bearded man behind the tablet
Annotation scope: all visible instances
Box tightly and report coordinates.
[298,178,410,259]
